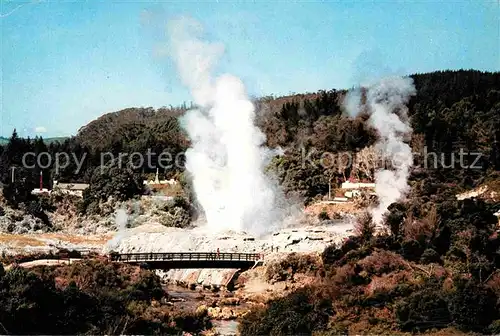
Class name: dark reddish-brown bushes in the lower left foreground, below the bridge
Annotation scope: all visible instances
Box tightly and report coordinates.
[0,261,211,335]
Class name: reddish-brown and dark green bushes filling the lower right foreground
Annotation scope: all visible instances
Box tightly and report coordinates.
[240,200,500,336]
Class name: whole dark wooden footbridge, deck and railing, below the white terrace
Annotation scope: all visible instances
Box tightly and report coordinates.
[110,252,263,270]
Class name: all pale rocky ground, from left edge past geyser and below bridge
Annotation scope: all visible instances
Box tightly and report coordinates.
[0,194,360,327]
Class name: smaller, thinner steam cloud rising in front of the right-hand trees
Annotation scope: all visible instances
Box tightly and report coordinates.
[344,77,416,224]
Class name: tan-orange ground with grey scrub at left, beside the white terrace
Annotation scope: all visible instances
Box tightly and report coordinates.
[0,196,195,255]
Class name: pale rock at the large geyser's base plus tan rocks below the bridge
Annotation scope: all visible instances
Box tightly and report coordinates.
[112,220,352,320]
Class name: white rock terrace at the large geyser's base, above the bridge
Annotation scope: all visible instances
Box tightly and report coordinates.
[103,220,352,255]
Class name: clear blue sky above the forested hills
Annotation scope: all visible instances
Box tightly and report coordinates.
[0,0,500,137]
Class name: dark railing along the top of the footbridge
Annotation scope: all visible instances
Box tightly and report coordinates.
[110,252,262,262]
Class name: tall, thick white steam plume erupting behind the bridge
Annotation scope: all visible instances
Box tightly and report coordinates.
[169,18,281,234]
